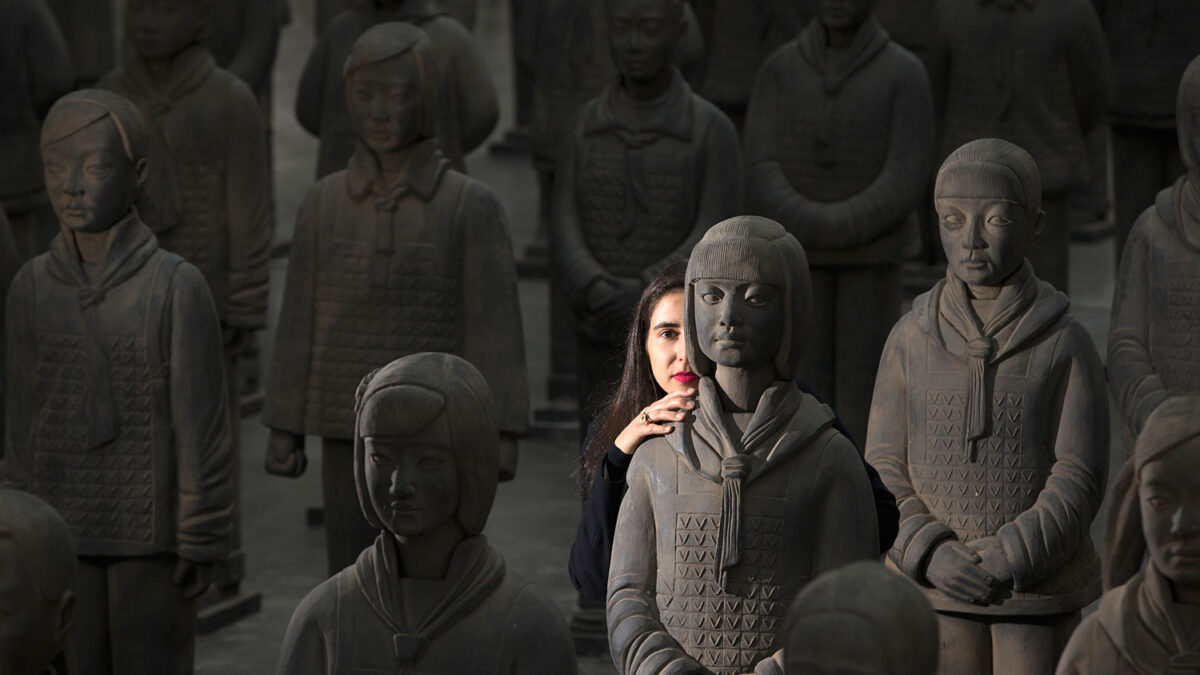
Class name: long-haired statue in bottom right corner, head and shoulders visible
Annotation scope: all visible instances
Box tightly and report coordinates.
[1057,395,1200,675]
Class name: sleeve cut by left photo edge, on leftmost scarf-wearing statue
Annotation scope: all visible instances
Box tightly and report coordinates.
[0,263,37,490]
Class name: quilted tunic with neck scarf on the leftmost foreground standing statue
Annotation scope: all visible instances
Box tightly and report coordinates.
[6,211,233,562]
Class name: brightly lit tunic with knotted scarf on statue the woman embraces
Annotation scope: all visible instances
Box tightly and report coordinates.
[608,377,880,675]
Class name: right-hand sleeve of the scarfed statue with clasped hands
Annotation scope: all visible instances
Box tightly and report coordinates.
[996,322,1109,591]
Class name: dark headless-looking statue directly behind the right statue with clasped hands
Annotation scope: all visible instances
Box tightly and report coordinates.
[926,0,1121,293]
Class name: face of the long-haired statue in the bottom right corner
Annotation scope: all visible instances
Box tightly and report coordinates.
[1138,438,1200,587]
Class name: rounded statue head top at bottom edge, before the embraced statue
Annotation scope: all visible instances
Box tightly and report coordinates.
[784,561,937,675]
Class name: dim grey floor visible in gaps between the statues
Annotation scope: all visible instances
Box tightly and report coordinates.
[196,0,1120,675]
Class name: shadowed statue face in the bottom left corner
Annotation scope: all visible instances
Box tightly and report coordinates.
[0,537,62,675]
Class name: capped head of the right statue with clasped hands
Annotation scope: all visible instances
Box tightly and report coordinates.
[934,138,1046,286]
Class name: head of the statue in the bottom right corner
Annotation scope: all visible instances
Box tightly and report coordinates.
[1133,396,1200,591]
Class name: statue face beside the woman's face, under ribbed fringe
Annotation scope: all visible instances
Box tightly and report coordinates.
[692,279,784,369]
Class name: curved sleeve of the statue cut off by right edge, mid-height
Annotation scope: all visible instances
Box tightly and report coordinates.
[1108,208,1169,432]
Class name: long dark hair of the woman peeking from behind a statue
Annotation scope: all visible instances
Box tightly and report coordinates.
[578,261,688,496]
